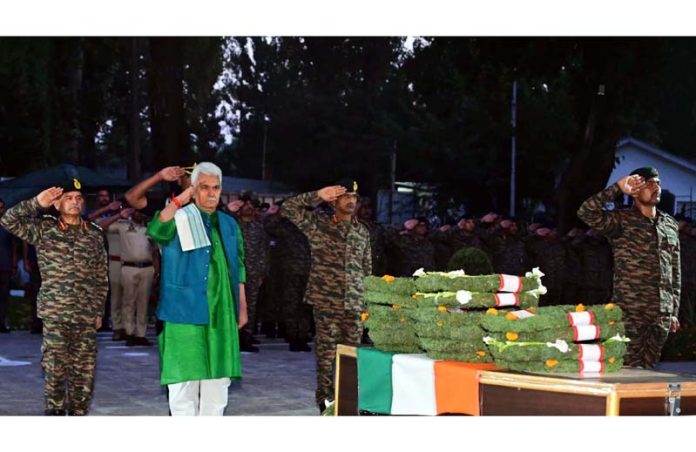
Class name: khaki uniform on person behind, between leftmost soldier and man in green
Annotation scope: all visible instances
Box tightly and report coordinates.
[111,221,155,337]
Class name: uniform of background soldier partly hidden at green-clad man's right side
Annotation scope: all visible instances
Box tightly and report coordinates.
[234,213,269,340]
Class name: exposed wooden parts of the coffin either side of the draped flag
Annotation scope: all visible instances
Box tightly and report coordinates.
[335,345,696,416]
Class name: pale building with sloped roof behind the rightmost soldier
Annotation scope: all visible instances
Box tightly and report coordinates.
[607,137,696,218]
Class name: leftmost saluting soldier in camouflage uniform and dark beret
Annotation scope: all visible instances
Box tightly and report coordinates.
[0,179,108,415]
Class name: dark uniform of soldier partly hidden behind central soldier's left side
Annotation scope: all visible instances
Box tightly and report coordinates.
[263,215,311,343]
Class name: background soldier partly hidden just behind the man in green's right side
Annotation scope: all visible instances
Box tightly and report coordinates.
[227,192,269,353]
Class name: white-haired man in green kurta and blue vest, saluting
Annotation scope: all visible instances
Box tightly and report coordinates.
[148,162,247,415]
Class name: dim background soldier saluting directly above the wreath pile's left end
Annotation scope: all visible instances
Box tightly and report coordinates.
[386,218,435,276]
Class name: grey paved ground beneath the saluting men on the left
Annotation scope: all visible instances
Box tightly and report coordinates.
[0,331,318,416]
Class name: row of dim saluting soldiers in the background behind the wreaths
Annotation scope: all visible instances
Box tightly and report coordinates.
[358,205,696,324]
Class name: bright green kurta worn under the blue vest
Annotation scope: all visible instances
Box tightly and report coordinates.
[148,211,246,385]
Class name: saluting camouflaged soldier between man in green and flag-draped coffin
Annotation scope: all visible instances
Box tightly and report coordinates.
[282,181,372,411]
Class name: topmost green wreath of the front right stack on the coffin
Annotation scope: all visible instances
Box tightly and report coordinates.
[481,304,622,332]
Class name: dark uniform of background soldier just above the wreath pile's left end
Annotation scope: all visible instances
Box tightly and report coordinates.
[387,232,435,276]
